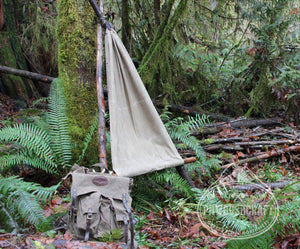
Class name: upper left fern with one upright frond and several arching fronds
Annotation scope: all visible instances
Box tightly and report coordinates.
[0,79,71,174]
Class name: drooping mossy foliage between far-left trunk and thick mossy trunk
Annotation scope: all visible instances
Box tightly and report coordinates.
[20,0,57,75]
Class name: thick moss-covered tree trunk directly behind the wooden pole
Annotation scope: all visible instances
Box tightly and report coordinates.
[57,0,97,160]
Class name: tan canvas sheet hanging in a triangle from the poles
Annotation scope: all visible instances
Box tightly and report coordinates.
[105,30,183,177]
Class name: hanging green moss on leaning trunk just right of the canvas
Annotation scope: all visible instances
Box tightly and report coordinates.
[138,0,188,101]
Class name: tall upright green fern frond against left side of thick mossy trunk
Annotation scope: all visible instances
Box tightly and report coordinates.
[47,79,72,169]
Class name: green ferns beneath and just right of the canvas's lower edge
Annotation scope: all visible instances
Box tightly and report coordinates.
[134,110,219,205]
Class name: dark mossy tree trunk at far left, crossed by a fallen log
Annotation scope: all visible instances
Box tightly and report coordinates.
[0,0,39,99]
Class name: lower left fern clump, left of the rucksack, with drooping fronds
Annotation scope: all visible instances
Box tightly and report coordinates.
[0,176,57,233]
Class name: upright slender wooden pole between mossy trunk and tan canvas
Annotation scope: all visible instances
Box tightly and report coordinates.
[96,0,107,168]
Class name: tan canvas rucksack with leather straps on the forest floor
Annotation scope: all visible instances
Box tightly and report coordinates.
[67,164,135,248]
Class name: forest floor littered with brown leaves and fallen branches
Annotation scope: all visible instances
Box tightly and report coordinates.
[0,96,300,249]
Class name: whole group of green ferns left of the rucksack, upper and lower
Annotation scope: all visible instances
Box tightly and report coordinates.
[0,79,71,232]
